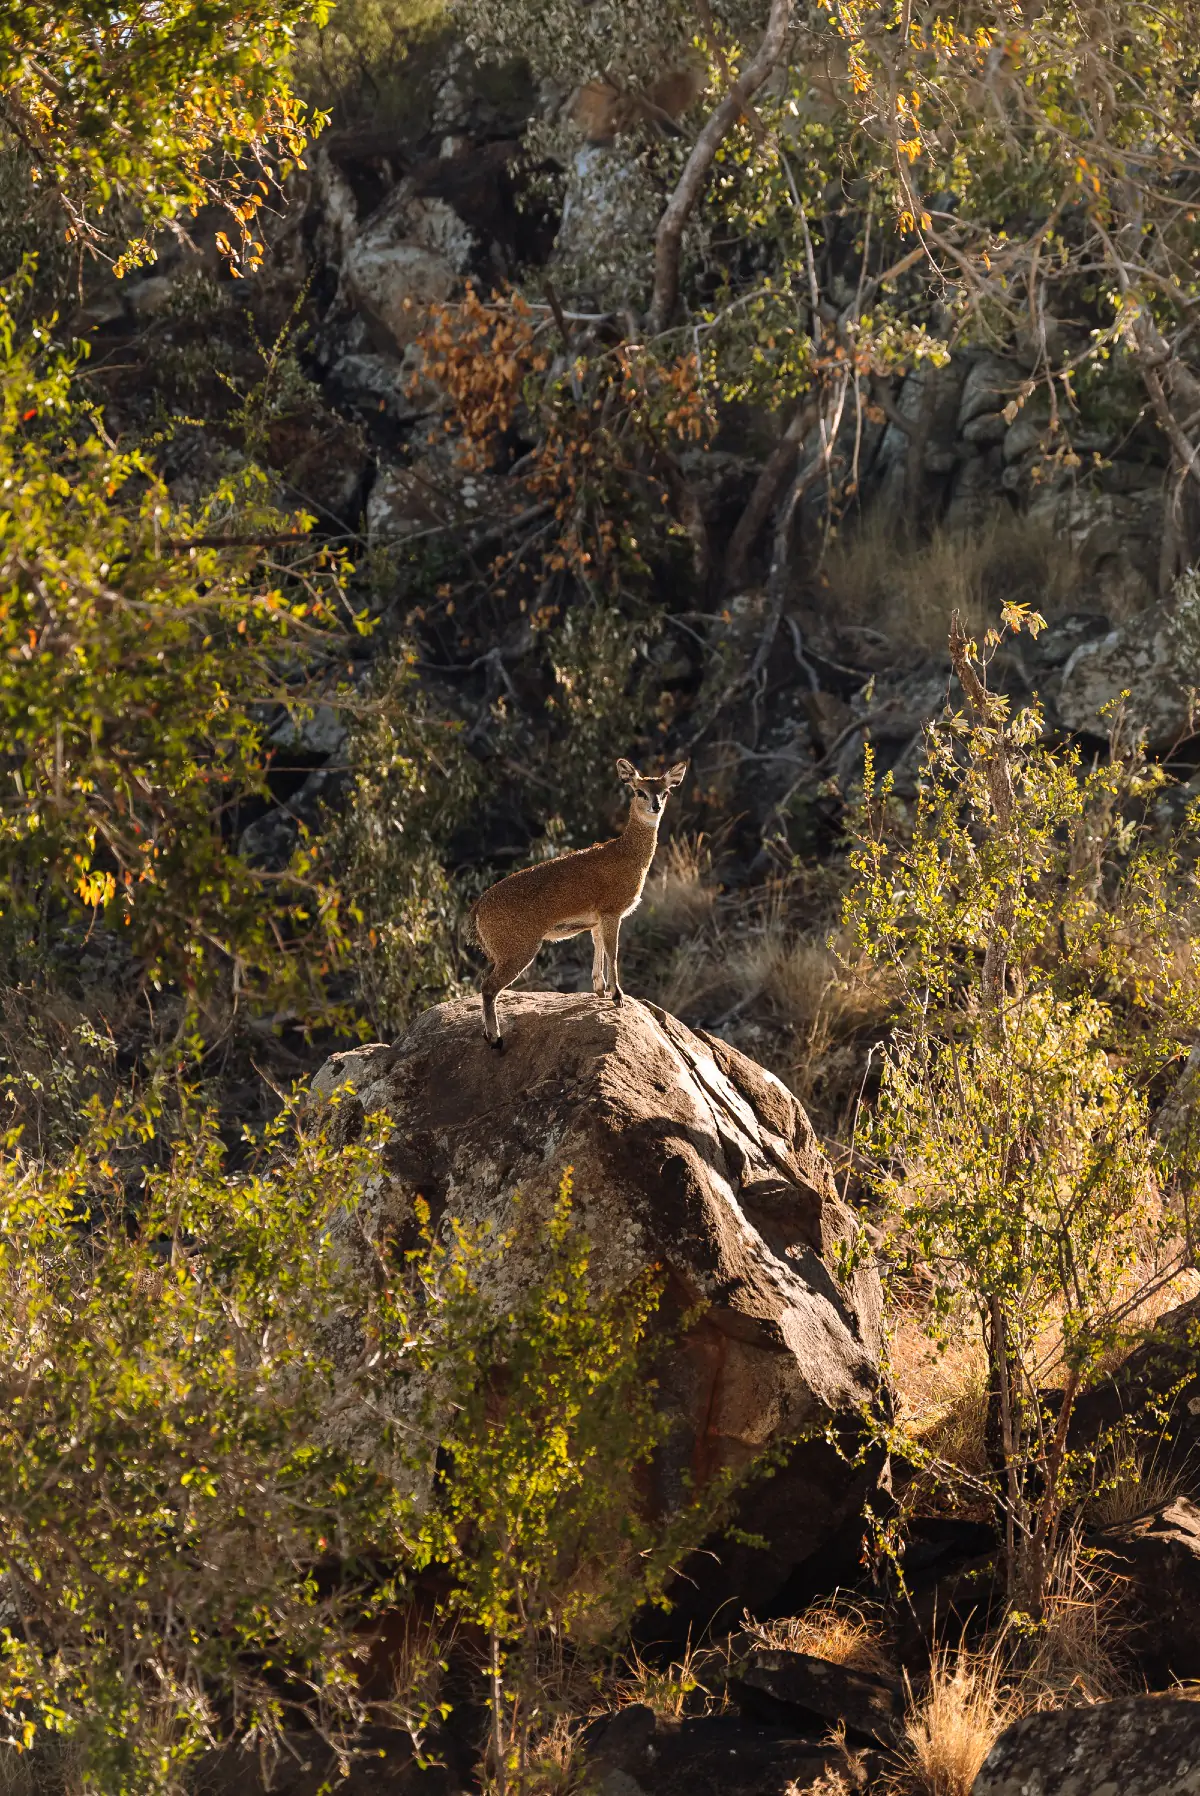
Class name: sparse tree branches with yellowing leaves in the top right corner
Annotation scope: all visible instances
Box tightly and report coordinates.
[830,0,1200,580]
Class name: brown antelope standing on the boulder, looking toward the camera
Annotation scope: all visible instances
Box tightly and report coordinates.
[471,760,688,1052]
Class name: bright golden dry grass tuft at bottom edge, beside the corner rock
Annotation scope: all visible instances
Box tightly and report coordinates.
[889,1649,1019,1796]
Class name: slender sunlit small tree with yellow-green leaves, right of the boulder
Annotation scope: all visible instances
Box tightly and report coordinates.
[846,611,1196,1622]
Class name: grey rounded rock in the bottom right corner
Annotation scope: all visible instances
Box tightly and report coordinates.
[972,1695,1200,1796]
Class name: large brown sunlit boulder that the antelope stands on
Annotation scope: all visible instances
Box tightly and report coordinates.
[313,993,880,1616]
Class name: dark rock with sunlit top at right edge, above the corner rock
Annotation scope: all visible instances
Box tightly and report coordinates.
[1098,1498,1200,1688]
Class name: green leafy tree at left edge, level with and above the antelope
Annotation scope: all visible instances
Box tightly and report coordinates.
[0,280,355,1002]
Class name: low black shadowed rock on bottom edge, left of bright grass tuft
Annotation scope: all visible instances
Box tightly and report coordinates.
[584,1704,866,1796]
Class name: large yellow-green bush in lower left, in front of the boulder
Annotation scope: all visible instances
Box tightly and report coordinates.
[0,1103,732,1796]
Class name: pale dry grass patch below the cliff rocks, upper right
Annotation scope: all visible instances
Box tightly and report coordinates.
[823,510,1087,654]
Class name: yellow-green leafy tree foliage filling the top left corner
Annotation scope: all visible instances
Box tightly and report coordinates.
[0,0,329,273]
